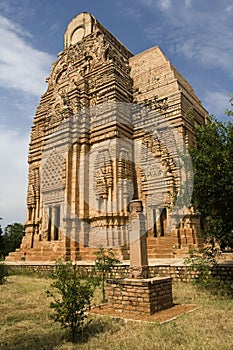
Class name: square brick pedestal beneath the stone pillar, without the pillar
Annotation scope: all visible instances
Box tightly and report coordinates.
[107,277,173,315]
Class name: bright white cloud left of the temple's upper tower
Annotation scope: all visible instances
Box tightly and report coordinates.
[0,16,52,96]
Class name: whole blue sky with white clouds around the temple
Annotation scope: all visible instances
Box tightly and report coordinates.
[0,0,233,226]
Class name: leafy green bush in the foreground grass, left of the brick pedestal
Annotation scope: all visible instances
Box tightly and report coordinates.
[47,261,95,342]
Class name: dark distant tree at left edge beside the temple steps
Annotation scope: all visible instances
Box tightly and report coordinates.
[2,222,24,256]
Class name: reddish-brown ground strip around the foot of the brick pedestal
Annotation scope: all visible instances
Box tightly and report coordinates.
[90,304,199,323]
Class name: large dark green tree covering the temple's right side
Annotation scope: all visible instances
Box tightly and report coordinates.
[190,116,233,249]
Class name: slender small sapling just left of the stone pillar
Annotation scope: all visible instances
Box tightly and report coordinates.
[95,247,120,302]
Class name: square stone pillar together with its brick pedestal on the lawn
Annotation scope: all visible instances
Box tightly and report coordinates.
[107,200,173,315]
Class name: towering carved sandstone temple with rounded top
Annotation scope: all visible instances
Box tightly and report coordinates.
[8,13,208,261]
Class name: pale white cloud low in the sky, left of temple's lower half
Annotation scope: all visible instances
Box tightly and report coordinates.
[0,125,29,226]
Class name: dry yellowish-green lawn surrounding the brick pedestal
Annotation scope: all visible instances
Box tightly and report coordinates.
[0,276,233,350]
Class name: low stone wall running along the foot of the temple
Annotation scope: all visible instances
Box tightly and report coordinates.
[7,262,233,282]
